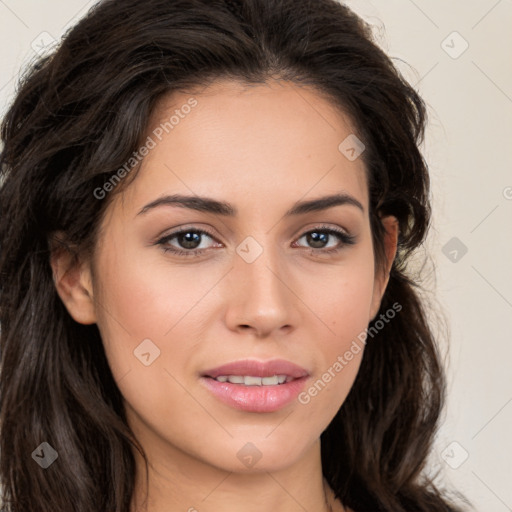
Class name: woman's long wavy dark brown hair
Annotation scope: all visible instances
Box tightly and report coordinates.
[0,0,464,512]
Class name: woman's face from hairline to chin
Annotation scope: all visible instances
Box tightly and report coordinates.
[57,82,394,472]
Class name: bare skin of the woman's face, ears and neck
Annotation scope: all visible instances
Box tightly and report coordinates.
[52,82,398,512]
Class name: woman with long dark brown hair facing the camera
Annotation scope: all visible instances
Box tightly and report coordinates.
[0,0,466,512]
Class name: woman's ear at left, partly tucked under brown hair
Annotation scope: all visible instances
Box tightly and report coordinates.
[50,232,96,325]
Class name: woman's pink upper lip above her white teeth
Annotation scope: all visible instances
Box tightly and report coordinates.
[202,359,309,379]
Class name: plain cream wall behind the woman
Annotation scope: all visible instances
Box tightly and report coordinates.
[0,0,512,512]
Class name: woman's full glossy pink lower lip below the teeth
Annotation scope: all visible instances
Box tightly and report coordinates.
[201,376,308,412]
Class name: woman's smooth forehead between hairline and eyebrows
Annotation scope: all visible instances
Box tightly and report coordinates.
[115,81,367,217]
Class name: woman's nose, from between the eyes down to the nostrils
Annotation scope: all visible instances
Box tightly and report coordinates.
[225,241,301,338]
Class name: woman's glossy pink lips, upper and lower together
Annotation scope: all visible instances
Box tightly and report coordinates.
[201,359,309,412]
